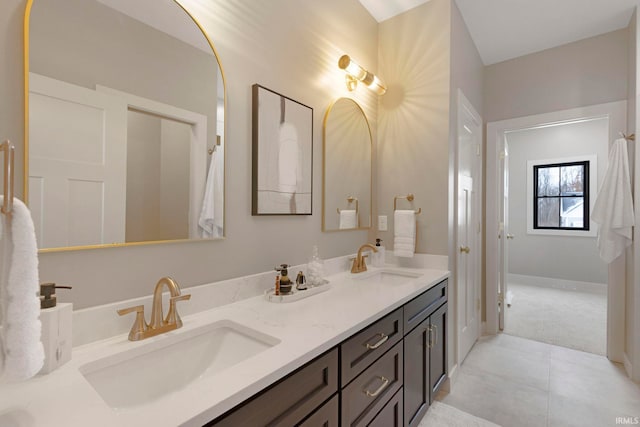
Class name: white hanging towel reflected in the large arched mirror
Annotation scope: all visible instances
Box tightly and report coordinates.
[198,146,224,238]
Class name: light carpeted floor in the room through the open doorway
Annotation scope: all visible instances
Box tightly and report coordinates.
[504,283,607,355]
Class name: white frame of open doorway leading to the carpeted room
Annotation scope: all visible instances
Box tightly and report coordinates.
[485,101,627,362]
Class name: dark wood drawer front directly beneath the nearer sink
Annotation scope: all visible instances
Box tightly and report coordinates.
[207,348,338,427]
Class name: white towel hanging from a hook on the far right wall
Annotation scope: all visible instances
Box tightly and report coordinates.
[591,138,634,263]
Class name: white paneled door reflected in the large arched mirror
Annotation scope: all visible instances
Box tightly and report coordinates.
[29,73,127,248]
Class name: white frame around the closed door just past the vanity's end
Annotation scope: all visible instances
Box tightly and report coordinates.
[453,89,483,363]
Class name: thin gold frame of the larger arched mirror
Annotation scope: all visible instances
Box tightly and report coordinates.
[22,0,228,253]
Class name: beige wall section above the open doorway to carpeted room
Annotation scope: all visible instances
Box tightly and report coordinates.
[484,30,628,122]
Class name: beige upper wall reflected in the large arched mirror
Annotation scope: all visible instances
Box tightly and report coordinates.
[29,0,218,154]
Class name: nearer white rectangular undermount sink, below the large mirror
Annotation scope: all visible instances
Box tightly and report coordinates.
[80,320,280,411]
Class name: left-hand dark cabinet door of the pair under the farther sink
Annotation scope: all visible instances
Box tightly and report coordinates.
[404,318,431,427]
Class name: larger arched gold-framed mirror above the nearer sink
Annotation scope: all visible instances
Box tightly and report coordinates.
[24,0,226,250]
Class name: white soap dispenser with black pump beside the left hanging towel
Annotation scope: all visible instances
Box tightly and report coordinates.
[40,283,73,374]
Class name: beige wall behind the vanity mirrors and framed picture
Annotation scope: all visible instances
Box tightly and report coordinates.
[0,0,380,308]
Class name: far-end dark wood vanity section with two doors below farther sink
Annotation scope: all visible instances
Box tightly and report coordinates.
[404,280,448,427]
